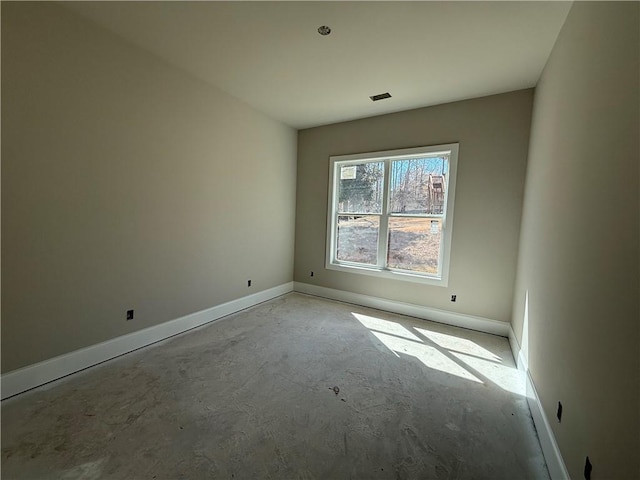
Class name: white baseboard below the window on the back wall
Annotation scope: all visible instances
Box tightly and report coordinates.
[294,282,509,337]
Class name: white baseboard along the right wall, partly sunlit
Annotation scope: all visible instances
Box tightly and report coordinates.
[509,327,570,480]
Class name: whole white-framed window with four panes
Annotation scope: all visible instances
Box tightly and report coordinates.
[326,144,458,286]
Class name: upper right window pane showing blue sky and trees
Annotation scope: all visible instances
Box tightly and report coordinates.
[390,155,449,215]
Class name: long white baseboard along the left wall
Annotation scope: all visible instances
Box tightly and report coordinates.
[0,282,293,400]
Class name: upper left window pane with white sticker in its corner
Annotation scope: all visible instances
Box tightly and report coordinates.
[338,162,384,213]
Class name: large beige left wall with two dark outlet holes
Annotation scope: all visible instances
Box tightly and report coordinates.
[2,2,296,372]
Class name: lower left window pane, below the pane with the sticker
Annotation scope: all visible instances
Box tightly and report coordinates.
[336,215,380,265]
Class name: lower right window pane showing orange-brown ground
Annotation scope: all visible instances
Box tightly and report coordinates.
[387,217,442,275]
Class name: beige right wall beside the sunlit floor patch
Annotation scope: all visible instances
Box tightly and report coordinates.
[513,2,640,479]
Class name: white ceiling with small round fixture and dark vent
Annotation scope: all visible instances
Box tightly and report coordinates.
[64,1,571,128]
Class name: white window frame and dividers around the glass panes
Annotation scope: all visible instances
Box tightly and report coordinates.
[325,143,459,287]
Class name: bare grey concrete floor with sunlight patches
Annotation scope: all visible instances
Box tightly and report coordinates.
[2,294,548,479]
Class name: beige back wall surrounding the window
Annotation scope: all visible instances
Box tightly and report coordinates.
[294,90,532,322]
